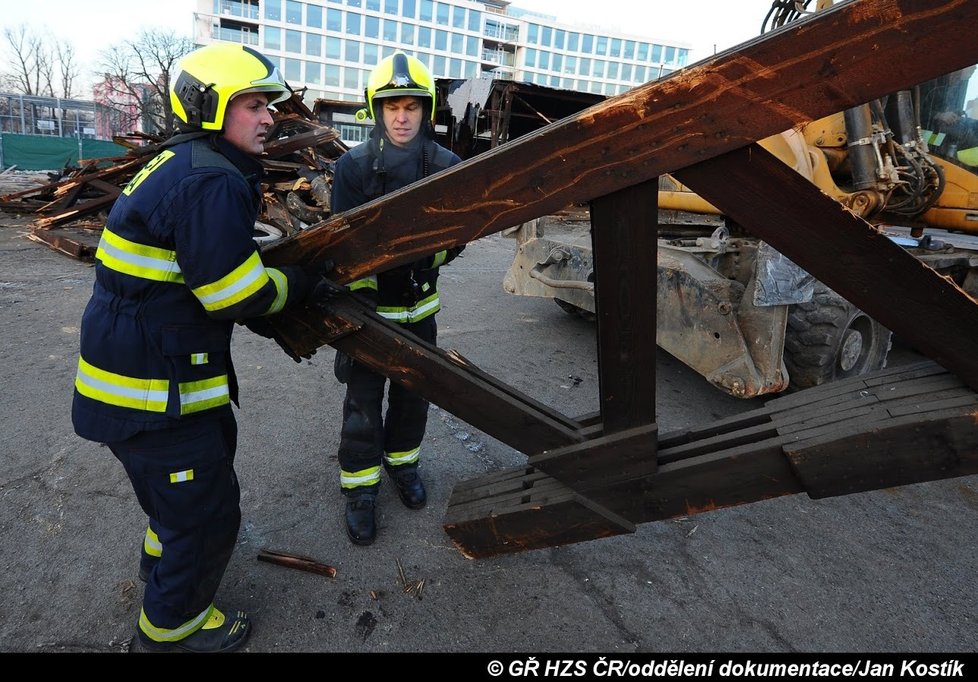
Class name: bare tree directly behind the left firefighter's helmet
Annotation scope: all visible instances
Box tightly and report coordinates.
[96,29,194,137]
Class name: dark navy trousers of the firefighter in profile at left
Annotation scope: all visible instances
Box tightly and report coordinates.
[108,414,241,629]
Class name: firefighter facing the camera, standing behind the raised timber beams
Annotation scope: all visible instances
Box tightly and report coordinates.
[332,52,462,545]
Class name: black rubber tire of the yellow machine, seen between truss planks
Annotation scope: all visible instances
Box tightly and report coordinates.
[784,283,892,390]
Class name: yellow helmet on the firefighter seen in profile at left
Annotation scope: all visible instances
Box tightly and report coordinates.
[170,43,292,130]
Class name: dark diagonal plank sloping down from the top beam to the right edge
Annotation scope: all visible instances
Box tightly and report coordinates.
[676,144,978,388]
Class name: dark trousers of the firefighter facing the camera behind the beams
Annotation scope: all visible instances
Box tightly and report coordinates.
[336,315,438,495]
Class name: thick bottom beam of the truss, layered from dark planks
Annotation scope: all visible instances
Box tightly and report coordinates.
[445,361,978,558]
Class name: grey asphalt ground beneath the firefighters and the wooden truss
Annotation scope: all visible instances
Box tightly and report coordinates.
[0,214,978,655]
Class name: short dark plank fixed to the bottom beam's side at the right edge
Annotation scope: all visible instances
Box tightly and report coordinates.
[785,406,978,499]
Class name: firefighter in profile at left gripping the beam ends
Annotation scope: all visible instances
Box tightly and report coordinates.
[72,44,324,652]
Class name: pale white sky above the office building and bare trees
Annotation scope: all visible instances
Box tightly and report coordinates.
[0,0,771,87]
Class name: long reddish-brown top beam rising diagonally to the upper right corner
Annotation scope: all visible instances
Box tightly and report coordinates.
[265,0,978,350]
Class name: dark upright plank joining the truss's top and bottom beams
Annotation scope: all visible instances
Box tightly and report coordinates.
[588,178,659,430]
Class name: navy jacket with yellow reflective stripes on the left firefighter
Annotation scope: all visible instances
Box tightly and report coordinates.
[72,135,307,442]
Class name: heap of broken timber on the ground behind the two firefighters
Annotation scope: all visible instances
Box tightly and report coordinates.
[0,93,347,261]
